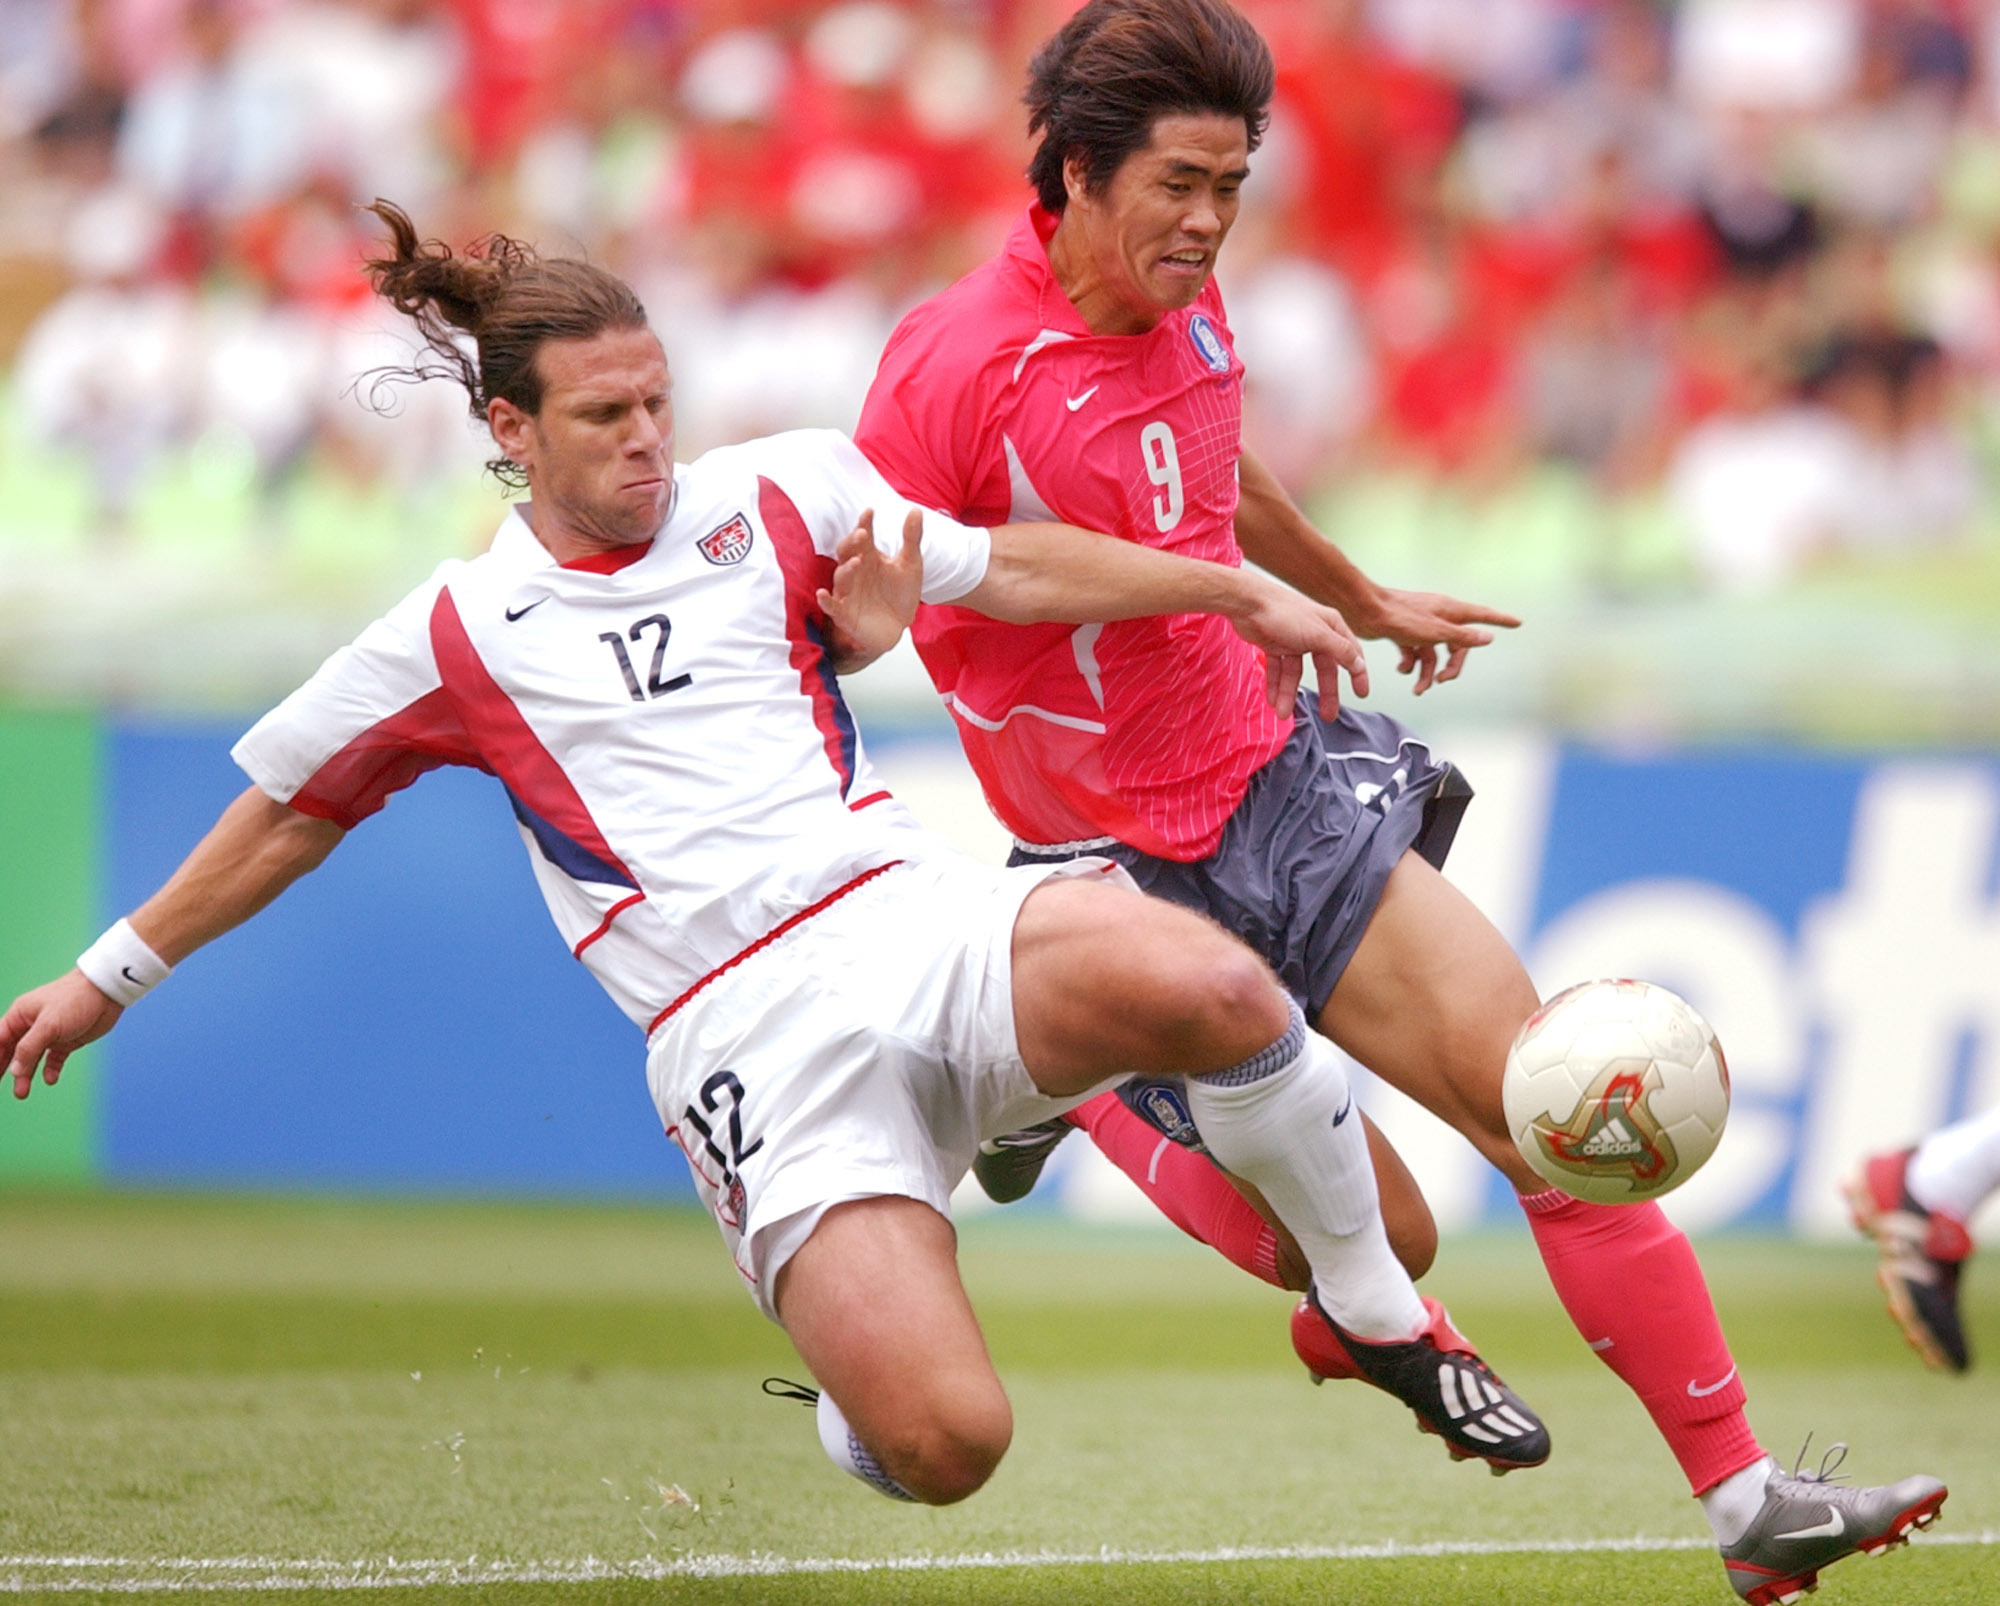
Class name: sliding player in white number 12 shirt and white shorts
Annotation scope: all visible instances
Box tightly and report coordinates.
[0,202,1548,1504]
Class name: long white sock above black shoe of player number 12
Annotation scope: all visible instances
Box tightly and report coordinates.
[1188,1004,1430,1340]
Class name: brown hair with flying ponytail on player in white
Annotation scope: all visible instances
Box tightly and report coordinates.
[364,200,646,488]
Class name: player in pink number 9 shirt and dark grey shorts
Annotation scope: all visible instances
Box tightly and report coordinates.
[856,0,1944,1602]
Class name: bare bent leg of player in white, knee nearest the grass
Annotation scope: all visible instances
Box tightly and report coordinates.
[776,1196,1014,1506]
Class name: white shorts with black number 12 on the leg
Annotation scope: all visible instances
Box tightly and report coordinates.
[646,856,1130,1320]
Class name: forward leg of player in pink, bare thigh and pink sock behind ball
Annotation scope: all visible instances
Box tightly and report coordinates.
[1320,854,1942,1598]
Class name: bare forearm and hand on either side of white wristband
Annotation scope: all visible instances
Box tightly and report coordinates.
[0,786,346,1098]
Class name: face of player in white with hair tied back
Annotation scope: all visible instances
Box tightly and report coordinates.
[486,328,674,548]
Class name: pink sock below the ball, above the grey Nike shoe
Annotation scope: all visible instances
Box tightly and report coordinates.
[1520,1188,1764,1494]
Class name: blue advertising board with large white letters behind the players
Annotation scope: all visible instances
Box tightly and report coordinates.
[50,724,2000,1232]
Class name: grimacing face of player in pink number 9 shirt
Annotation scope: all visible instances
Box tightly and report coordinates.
[1064,112,1250,328]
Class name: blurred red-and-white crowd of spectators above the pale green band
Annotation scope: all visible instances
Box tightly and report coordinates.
[0,0,2000,590]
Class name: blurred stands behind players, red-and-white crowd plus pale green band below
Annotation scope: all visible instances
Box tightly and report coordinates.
[0,0,2000,740]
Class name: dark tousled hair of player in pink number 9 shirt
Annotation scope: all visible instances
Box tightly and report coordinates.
[1022,0,1276,212]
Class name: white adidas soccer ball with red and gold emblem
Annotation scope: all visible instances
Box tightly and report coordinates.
[1500,980,1730,1204]
